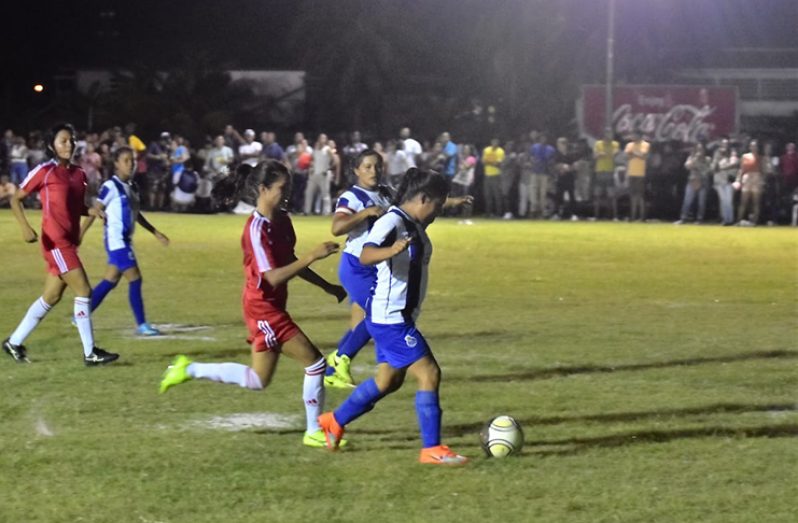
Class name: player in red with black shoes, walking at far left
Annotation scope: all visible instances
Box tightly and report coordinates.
[3,124,119,366]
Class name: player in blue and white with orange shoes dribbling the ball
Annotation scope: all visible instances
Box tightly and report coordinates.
[319,168,468,465]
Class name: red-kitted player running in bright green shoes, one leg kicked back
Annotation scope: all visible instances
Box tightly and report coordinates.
[160,160,346,448]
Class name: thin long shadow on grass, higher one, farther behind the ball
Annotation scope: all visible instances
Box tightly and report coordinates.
[460,350,798,382]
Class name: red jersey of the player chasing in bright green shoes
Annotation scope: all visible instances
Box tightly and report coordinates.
[241,211,296,317]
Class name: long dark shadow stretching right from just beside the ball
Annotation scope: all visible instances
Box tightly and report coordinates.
[527,424,798,456]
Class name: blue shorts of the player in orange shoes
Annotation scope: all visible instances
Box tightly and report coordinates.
[366,318,431,369]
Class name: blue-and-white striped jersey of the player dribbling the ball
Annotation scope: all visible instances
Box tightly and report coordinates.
[364,207,432,325]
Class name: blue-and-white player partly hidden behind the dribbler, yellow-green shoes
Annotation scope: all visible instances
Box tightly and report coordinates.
[324,149,392,388]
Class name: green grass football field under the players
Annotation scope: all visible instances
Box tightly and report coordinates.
[0,210,798,523]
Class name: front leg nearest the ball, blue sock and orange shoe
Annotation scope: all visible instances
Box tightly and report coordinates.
[408,352,468,465]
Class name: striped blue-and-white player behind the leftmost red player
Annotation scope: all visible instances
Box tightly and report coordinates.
[83,147,169,336]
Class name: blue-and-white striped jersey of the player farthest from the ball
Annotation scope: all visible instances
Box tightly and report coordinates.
[97,176,139,251]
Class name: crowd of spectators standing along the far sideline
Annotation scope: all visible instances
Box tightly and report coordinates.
[0,124,798,226]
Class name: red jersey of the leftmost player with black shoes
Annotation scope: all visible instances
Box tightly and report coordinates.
[19,160,88,251]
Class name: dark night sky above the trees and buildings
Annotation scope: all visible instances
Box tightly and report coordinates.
[6,0,798,74]
